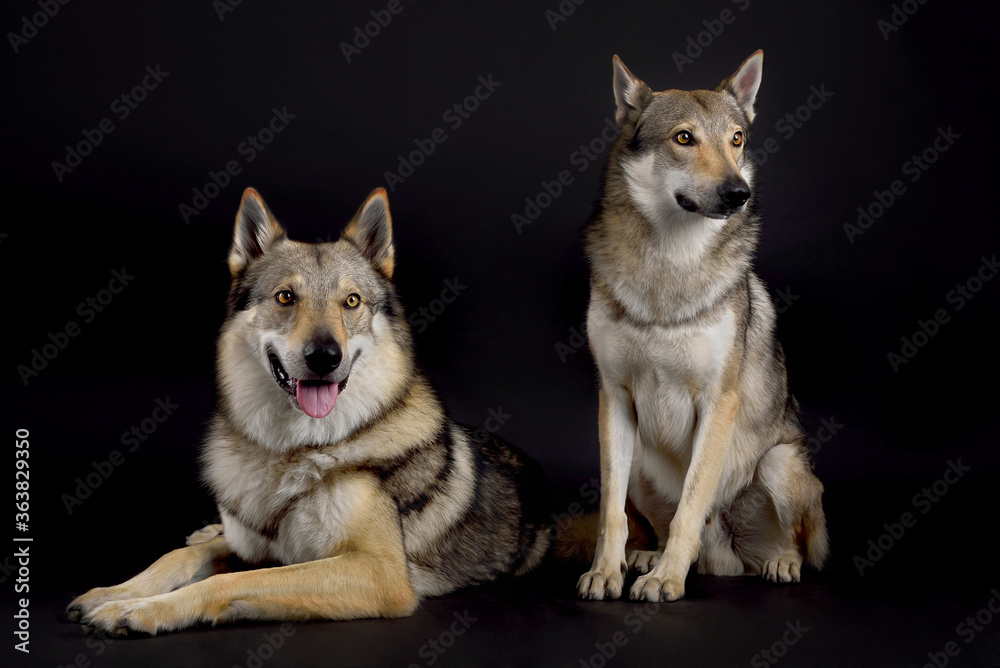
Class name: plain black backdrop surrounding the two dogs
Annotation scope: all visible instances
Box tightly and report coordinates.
[0,0,1000,666]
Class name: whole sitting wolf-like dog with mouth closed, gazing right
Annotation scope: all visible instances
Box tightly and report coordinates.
[573,52,828,601]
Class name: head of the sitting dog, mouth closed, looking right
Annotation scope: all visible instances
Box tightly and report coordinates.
[613,51,764,226]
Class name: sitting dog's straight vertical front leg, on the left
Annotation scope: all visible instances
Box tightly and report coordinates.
[577,387,638,600]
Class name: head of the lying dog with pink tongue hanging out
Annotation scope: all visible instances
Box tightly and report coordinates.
[219,188,410,438]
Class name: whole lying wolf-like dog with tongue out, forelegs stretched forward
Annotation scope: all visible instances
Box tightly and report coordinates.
[68,189,550,634]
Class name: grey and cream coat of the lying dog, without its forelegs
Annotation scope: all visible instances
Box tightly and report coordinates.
[203,187,549,596]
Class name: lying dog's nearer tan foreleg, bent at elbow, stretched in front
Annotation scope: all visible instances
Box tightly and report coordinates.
[82,482,418,635]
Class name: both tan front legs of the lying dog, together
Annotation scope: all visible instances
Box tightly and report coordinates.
[71,474,417,635]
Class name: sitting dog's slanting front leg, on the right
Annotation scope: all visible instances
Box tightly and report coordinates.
[630,392,739,602]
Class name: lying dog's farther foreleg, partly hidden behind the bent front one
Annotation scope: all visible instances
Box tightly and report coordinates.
[66,534,232,622]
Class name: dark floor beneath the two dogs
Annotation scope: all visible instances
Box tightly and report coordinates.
[5,574,1000,667]
